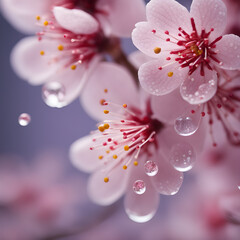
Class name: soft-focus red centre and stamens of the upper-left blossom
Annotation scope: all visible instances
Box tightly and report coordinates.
[37,16,107,70]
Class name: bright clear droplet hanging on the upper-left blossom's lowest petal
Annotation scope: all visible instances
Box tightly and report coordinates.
[42,82,66,108]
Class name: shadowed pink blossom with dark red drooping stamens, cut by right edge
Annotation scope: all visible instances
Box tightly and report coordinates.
[184,70,240,146]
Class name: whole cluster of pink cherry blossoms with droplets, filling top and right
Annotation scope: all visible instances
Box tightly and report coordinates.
[1,0,240,234]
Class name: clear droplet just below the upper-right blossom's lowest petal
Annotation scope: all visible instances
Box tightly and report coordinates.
[174,117,198,136]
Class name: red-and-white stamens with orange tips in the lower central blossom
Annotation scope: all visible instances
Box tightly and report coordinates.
[90,100,163,182]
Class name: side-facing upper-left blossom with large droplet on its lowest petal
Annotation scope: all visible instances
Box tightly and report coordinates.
[7,1,142,107]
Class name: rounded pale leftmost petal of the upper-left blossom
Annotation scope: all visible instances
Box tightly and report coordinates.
[11,37,59,85]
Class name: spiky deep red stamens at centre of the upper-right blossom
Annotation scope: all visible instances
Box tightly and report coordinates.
[152,18,223,76]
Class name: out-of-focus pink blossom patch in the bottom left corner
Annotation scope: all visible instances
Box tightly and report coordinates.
[0,153,87,240]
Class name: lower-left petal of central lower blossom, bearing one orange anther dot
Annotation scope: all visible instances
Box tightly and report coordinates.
[87,168,128,205]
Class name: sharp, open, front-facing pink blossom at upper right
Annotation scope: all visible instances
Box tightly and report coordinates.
[132,0,240,101]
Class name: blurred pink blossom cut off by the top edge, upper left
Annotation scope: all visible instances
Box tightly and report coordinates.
[1,0,145,37]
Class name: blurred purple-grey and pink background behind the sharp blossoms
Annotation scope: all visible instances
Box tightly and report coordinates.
[0,0,240,240]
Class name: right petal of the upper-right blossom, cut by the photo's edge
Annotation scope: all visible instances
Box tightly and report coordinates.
[216,34,240,70]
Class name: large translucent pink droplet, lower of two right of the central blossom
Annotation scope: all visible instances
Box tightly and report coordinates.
[170,143,196,172]
